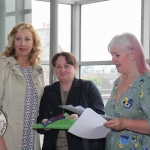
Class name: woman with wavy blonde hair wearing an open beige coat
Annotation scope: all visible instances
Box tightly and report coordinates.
[0,23,44,150]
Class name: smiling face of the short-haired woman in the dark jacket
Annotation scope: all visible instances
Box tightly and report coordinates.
[54,56,77,82]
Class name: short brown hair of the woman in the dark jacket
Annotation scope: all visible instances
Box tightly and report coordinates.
[51,52,77,68]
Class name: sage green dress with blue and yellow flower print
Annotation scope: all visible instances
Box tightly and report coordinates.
[105,73,150,150]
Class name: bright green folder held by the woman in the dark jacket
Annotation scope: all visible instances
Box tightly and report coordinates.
[33,113,75,129]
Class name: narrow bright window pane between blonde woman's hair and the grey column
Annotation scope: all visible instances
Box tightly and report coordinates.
[32,0,50,61]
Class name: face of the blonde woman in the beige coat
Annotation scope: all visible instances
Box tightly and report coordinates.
[14,29,33,57]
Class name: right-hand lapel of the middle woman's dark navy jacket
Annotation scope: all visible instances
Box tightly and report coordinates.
[66,78,81,105]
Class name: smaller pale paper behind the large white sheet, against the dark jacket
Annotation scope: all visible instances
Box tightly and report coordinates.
[59,105,85,115]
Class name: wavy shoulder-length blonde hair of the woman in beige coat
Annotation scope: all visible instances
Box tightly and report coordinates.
[2,22,41,65]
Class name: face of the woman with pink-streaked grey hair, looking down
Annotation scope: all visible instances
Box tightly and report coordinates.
[110,47,135,74]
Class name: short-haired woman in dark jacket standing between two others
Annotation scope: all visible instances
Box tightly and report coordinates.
[38,52,105,150]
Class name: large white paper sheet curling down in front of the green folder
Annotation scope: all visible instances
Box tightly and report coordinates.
[68,108,110,139]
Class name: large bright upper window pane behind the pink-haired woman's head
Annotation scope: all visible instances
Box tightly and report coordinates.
[81,0,141,61]
